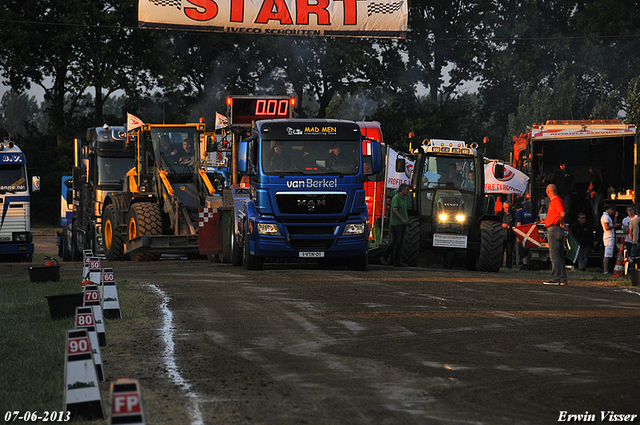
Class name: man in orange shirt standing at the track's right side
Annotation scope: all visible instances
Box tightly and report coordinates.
[544,184,567,285]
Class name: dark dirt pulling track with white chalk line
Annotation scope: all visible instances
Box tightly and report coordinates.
[15,230,640,425]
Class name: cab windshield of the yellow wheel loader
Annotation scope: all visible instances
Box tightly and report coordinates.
[151,127,196,174]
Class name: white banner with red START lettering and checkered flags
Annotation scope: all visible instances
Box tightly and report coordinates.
[138,0,409,38]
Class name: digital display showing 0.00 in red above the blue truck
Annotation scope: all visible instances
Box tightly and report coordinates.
[227,96,295,125]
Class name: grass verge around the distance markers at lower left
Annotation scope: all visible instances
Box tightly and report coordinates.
[0,278,150,424]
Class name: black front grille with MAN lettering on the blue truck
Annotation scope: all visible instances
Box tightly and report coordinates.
[276,193,347,214]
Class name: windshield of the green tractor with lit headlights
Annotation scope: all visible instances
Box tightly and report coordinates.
[422,156,476,192]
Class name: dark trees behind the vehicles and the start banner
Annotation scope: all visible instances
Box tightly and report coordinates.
[0,0,640,224]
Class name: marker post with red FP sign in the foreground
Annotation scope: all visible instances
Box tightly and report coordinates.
[110,379,147,425]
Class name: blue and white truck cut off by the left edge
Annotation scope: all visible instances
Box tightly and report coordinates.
[0,141,40,262]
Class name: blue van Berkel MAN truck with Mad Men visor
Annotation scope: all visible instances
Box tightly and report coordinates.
[234,119,382,270]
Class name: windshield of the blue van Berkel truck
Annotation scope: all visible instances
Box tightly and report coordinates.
[262,140,361,175]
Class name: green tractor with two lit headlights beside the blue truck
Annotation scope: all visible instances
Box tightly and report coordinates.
[396,140,503,272]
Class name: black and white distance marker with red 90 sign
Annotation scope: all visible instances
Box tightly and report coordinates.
[64,329,104,420]
